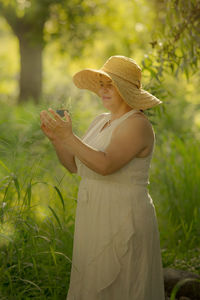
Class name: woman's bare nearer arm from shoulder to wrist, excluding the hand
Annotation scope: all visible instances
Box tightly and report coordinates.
[61,117,149,175]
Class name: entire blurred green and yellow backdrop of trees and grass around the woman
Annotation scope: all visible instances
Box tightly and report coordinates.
[0,0,200,300]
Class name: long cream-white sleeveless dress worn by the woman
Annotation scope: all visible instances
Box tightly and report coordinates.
[67,110,164,300]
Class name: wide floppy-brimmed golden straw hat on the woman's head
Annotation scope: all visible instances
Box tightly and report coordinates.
[73,55,162,110]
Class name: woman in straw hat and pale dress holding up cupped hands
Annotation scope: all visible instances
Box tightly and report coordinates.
[41,56,164,300]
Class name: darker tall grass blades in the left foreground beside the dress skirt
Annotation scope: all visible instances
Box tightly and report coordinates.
[0,175,75,299]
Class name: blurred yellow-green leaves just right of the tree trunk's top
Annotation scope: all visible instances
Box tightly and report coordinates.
[44,0,102,58]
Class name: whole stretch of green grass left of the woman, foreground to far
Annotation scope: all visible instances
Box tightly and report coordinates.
[0,100,82,299]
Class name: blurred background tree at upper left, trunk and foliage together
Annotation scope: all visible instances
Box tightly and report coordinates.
[0,0,99,103]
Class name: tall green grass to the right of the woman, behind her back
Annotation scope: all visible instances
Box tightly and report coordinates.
[150,132,200,273]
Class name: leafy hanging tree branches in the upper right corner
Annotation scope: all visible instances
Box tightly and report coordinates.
[143,0,200,80]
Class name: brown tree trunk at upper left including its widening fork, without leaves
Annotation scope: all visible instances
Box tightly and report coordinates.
[0,2,45,103]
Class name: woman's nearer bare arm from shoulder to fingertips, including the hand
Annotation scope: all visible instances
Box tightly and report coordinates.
[41,109,151,175]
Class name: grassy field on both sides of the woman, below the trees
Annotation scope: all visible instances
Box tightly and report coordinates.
[0,103,200,300]
